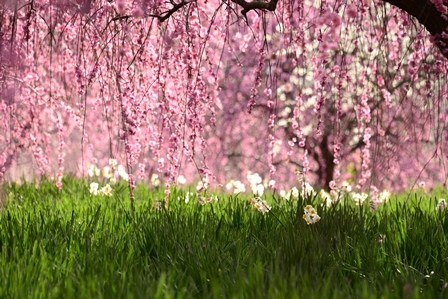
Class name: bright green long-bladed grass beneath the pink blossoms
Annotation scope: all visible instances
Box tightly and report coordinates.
[0,180,448,298]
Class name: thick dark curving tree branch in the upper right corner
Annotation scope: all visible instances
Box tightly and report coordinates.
[384,0,448,58]
